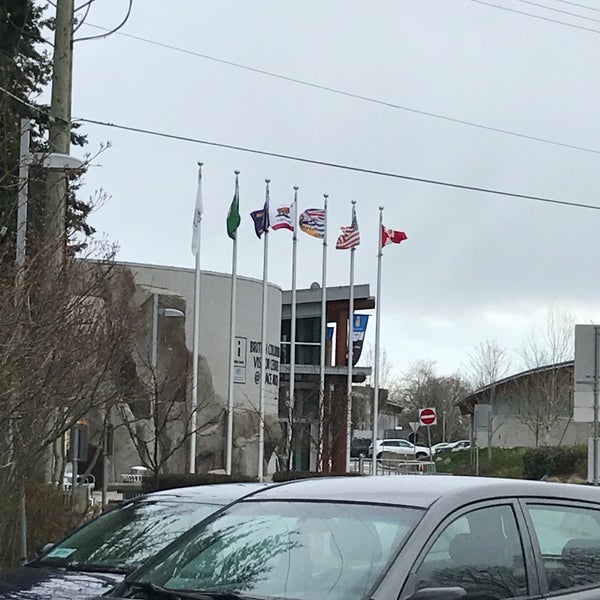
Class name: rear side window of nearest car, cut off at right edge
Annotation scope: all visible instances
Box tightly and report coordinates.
[528,504,600,591]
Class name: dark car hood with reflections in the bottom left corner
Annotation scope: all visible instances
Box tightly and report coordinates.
[0,567,125,600]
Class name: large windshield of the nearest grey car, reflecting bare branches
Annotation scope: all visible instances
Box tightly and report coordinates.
[132,501,423,600]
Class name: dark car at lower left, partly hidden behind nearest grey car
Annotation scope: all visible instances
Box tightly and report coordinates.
[0,483,264,600]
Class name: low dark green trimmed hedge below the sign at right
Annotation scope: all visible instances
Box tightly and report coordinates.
[523,446,587,479]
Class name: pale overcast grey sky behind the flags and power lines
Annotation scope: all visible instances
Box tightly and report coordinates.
[62,0,600,380]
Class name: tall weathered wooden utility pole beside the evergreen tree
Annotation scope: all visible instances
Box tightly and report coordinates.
[46,0,74,264]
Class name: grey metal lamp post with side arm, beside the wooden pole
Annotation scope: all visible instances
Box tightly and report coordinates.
[15,119,83,561]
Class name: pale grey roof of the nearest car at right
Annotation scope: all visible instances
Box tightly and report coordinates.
[243,475,600,508]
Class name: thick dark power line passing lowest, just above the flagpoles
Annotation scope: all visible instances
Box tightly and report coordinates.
[76,118,600,210]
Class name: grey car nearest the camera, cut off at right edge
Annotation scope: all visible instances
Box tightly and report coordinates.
[107,475,600,600]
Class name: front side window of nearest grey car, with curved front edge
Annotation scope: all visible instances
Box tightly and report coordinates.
[413,505,528,600]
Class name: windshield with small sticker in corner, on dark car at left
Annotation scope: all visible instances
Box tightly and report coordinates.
[34,500,221,571]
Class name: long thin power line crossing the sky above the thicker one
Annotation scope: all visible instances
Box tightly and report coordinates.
[85,24,600,154]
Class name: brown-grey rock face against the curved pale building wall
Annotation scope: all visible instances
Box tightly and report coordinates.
[90,267,282,481]
